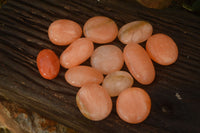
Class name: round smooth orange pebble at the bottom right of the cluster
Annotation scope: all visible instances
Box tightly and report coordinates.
[116,87,151,124]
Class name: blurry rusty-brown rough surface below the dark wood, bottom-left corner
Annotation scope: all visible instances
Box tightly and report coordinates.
[0,98,77,133]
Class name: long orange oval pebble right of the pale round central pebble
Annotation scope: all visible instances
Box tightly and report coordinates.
[123,43,155,85]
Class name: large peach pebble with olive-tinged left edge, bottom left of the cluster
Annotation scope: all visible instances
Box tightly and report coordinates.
[76,83,112,121]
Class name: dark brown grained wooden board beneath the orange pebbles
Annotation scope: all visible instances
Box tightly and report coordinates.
[0,0,200,133]
